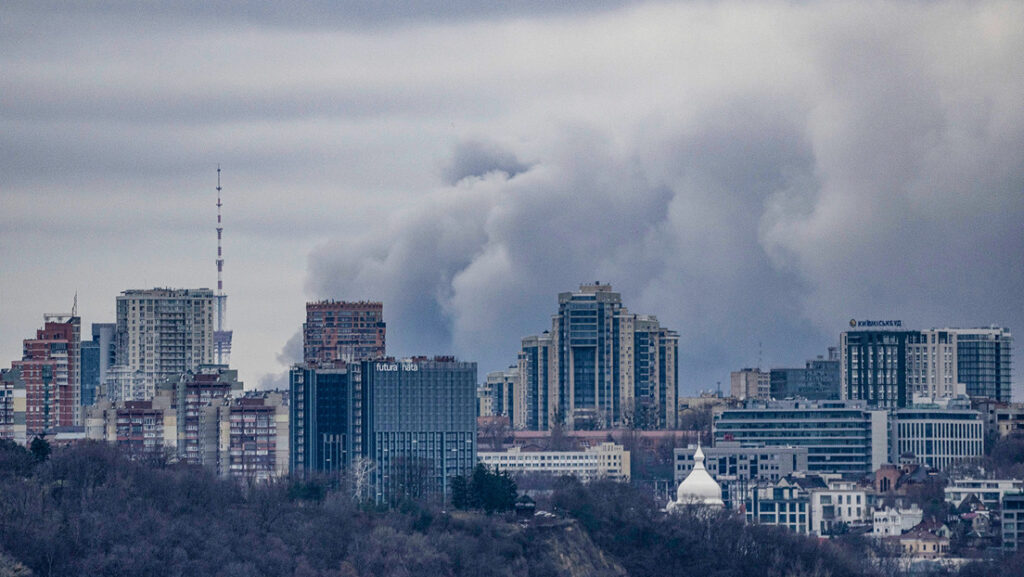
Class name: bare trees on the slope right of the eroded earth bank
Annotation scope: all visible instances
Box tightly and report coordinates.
[552,478,1024,577]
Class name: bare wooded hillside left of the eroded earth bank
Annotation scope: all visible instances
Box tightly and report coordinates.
[0,443,547,577]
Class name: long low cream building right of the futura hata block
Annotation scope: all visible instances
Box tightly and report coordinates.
[476,443,630,482]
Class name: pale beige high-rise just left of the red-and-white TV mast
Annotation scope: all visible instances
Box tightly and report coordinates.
[115,288,215,397]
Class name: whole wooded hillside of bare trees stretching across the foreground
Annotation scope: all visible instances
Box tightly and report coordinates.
[0,442,1022,577]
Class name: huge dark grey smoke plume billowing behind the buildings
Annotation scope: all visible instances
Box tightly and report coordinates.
[301,2,1024,390]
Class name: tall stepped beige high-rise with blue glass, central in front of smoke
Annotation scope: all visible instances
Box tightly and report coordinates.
[519,283,679,429]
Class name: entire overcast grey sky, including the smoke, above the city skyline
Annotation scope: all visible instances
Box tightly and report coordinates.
[0,0,1024,397]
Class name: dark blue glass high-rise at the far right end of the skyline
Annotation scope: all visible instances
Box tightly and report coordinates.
[949,327,1014,403]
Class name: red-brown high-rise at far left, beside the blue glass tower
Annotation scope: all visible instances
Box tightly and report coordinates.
[11,315,82,438]
